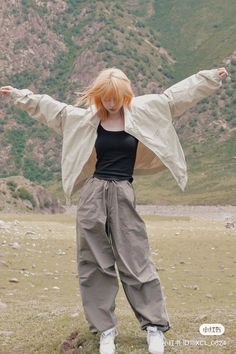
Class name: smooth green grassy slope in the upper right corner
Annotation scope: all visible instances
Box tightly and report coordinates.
[147,0,236,80]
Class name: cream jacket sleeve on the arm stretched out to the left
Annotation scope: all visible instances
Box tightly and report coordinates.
[7,87,85,133]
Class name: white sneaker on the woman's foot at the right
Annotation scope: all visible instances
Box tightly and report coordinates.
[147,326,164,354]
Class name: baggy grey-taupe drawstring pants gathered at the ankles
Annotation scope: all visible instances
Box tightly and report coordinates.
[76,177,170,333]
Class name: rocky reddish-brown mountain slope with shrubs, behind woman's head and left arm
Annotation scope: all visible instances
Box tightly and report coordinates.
[0,0,170,181]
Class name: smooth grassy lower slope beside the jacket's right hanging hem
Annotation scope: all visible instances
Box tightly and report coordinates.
[134,133,236,205]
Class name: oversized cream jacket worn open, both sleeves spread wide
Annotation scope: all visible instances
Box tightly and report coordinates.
[6,69,221,200]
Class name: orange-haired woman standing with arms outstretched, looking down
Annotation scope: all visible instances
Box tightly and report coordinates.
[0,68,227,354]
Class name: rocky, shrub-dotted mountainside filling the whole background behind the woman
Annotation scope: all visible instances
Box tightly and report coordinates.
[0,0,236,203]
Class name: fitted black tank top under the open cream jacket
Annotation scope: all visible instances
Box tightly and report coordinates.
[93,124,138,182]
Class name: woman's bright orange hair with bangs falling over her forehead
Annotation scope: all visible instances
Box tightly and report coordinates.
[76,68,134,120]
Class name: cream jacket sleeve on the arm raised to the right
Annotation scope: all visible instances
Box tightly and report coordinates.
[163,69,222,118]
